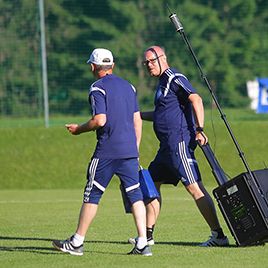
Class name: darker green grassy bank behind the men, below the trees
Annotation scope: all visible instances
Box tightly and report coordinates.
[0,110,268,189]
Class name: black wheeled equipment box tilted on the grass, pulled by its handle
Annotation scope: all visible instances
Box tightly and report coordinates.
[213,169,268,246]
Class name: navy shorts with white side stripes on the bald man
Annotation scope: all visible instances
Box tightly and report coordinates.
[148,139,201,186]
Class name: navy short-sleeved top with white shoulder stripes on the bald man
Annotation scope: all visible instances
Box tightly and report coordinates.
[153,68,196,150]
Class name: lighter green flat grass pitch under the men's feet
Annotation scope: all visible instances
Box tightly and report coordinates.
[0,186,268,268]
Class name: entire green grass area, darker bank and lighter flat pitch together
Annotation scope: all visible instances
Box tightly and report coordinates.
[0,110,268,268]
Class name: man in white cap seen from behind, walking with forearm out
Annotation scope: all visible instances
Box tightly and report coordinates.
[52,48,152,256]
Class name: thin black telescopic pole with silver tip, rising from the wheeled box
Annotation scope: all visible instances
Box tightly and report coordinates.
[169,10,255,178]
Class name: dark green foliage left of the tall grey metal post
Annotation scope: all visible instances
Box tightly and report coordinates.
[0,0,41,116]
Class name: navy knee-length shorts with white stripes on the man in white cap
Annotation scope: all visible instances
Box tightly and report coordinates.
[84,158,143,203]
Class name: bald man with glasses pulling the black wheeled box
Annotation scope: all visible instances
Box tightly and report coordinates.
[129,46,229,247]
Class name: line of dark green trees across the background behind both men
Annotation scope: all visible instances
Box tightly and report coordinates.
[0,0,268,115]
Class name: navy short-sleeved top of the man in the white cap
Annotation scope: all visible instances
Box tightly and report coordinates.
[89,74,139,159]
